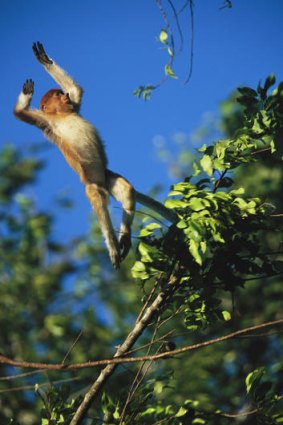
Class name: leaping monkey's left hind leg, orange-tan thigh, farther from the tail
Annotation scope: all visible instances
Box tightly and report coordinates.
[85,183,121,269]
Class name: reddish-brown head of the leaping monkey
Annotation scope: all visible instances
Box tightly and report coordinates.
[40,89,74,115]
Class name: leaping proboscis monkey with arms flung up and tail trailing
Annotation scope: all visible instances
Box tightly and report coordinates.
[14,42,176,268]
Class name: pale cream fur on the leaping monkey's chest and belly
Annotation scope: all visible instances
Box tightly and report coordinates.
[52,114,106,166]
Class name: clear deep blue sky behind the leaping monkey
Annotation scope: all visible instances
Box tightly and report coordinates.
[0,0,283,237]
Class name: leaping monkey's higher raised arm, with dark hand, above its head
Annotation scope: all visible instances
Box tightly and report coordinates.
[32,42,83,109]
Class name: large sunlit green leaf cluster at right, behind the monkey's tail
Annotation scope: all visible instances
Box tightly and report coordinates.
[132,77,283,329]
